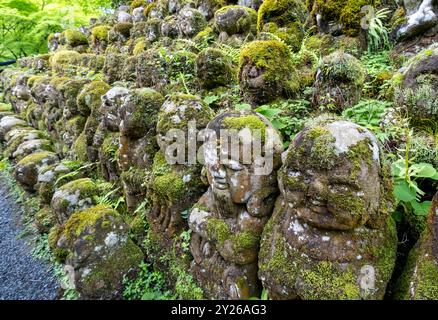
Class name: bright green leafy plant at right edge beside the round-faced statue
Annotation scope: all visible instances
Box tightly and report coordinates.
[391,132,438,216]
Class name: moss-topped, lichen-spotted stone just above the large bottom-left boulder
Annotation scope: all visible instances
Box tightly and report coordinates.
[50,178,99,224]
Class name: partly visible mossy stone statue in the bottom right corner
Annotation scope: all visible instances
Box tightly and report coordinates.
[395,193,438,300]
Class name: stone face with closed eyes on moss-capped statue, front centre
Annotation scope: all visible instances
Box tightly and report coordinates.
[204,112,282,214]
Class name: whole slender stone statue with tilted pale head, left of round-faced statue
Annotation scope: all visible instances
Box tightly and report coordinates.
[189,111,283,299]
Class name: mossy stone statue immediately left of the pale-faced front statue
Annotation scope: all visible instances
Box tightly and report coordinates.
[148,94,214,250]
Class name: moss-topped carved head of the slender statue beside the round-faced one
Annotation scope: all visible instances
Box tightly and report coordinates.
[204,111,283,216]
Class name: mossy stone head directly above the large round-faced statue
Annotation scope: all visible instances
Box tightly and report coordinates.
[312,51,365,111]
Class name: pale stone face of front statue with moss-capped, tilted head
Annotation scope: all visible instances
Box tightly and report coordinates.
[204,112,282,214]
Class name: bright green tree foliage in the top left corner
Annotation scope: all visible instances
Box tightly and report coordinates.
[0,0,111,60]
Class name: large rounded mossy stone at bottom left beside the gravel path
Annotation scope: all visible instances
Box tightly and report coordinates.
[53,205,143,299]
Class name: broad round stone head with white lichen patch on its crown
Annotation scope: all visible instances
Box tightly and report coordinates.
[279,121,382,230]
